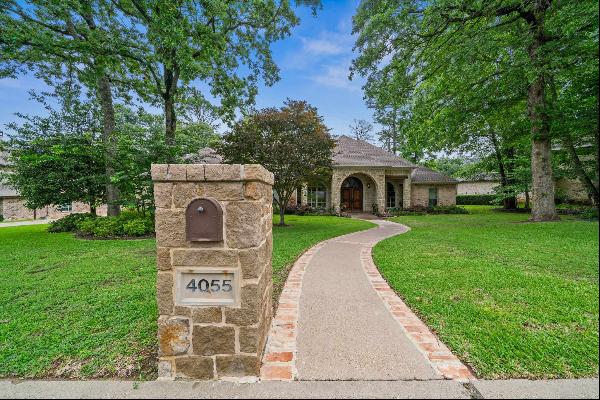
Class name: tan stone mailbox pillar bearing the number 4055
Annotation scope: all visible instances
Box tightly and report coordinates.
[152,164,273,379]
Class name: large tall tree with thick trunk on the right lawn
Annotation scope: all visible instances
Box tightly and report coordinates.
[353,0,598,221]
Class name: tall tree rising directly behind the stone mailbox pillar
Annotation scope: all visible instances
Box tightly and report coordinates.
[105,0,320,145]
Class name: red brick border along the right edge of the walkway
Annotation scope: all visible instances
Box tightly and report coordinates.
[361,244,475,382]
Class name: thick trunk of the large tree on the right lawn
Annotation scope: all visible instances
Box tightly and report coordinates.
[527,0,558,222]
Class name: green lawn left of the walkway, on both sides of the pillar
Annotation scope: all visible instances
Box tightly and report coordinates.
[0,216,371,379]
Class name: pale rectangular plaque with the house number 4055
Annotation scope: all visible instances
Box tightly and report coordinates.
[176,268,240,307]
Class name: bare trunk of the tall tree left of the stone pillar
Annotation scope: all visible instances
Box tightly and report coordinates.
[98,74,121,216]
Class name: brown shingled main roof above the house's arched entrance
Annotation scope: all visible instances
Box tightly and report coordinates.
[333,135,417,168]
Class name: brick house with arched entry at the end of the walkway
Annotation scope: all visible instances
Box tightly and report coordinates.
[295,136,458,212]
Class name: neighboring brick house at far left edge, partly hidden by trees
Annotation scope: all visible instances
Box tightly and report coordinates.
[0,152,106,221]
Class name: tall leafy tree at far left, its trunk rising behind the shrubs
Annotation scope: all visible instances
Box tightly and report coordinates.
[0,0,122,215]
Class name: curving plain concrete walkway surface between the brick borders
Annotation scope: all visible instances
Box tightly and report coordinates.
[296,220,442,380]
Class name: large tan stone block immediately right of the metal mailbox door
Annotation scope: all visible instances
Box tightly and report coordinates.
[225,202,263,249]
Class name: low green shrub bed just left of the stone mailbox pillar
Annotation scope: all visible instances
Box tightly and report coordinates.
[77,211,154,239]
